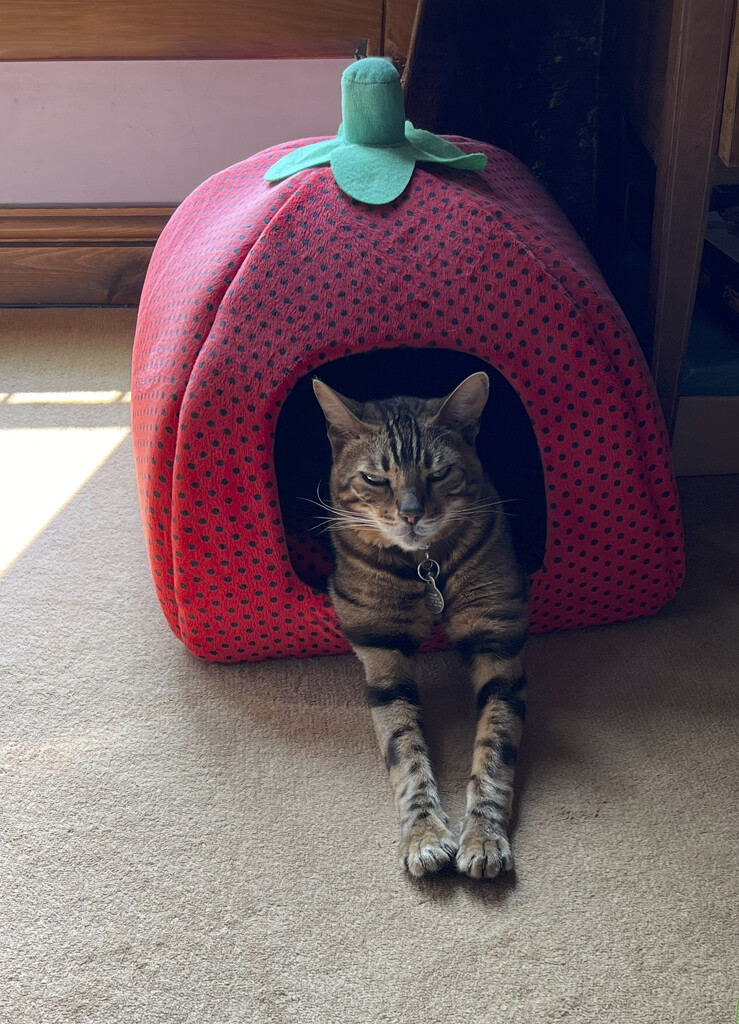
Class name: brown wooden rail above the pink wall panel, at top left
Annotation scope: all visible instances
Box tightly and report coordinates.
[0,0,384,60]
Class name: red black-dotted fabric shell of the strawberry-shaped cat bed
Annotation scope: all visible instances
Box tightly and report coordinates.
[132,136,684,662]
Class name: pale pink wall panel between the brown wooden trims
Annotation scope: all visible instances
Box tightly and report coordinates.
[0,56,351,206]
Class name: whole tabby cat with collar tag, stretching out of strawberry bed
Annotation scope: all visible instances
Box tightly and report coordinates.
[313,373,528,879]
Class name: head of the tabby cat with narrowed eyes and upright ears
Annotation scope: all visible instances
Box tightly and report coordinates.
[313,372,489,551]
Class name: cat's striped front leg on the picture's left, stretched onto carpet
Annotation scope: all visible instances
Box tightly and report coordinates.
[354,646,457,878]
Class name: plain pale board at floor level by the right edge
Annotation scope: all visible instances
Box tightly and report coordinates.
[672,395,739,476]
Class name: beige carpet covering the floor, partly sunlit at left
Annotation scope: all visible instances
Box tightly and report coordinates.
[0,310,739,1024]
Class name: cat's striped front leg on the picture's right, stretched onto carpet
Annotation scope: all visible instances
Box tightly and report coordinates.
[457,637,526,879]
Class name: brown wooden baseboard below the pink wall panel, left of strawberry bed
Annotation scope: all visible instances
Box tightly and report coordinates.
[0,206,174,306]
